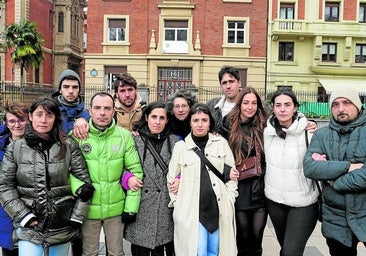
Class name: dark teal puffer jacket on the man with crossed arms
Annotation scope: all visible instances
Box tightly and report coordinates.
[304,110,366,246]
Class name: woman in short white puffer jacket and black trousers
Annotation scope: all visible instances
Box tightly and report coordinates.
[264,89,318,256]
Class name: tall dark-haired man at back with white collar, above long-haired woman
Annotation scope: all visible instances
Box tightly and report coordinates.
[206,66,241,132]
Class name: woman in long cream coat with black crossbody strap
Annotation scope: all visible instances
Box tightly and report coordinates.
[167,103,238,256]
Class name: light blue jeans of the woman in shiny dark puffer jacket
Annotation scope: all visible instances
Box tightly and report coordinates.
[18,240,70,256]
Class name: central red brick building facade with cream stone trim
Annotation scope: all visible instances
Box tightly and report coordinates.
[84,0,267,101]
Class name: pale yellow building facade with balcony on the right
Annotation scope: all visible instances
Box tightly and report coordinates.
[267,0,366,101]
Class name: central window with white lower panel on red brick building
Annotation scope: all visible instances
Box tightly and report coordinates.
[163,20,188,53]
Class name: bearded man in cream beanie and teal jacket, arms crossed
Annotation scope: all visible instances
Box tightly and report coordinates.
[304,86,366,256]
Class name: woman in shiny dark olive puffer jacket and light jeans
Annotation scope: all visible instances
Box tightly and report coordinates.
[0,97,92,256]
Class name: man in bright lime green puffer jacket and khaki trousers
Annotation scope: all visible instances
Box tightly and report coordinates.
[72,92,143,256]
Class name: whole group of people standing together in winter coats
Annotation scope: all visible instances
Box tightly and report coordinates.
[0,66,366,256]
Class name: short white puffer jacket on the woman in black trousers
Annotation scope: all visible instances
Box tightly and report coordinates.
[264,113,319,207]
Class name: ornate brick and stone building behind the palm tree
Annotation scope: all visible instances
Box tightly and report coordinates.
[0,0,86,87]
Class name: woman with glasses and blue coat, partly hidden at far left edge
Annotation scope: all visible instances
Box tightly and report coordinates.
[0,102,29,256]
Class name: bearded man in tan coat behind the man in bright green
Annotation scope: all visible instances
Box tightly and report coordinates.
[113,73,146,131]
